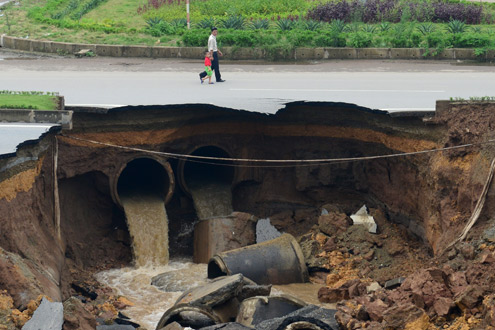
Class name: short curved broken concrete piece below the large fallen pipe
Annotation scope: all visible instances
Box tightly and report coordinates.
[236,295,307,327]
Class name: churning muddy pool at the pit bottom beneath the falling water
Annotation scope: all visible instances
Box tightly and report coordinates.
[95,260,207,330]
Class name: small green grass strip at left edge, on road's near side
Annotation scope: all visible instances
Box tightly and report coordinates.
[0,91,58,110]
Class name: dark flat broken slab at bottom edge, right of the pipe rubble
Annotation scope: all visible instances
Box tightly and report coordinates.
[256,305,339,330]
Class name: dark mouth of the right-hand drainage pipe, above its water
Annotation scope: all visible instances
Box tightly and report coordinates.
[179,146,235,196]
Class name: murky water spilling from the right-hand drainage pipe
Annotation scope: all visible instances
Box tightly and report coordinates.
[189,180,233,220]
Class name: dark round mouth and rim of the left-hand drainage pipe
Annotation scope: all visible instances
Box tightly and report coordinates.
[110,155,175,207]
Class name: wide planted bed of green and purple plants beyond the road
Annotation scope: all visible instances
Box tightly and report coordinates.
[0,0,495,56]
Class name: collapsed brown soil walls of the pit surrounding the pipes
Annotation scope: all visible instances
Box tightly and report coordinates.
[0,102,495,329]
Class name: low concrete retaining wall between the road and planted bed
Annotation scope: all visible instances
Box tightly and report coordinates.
[0,35,495,61]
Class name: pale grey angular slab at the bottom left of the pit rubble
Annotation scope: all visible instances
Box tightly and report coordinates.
[22,298,64,330]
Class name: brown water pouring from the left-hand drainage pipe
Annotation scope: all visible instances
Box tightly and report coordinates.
[121,192,169,267]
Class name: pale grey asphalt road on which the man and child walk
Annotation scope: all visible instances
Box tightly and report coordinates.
[0,49,495,113]
